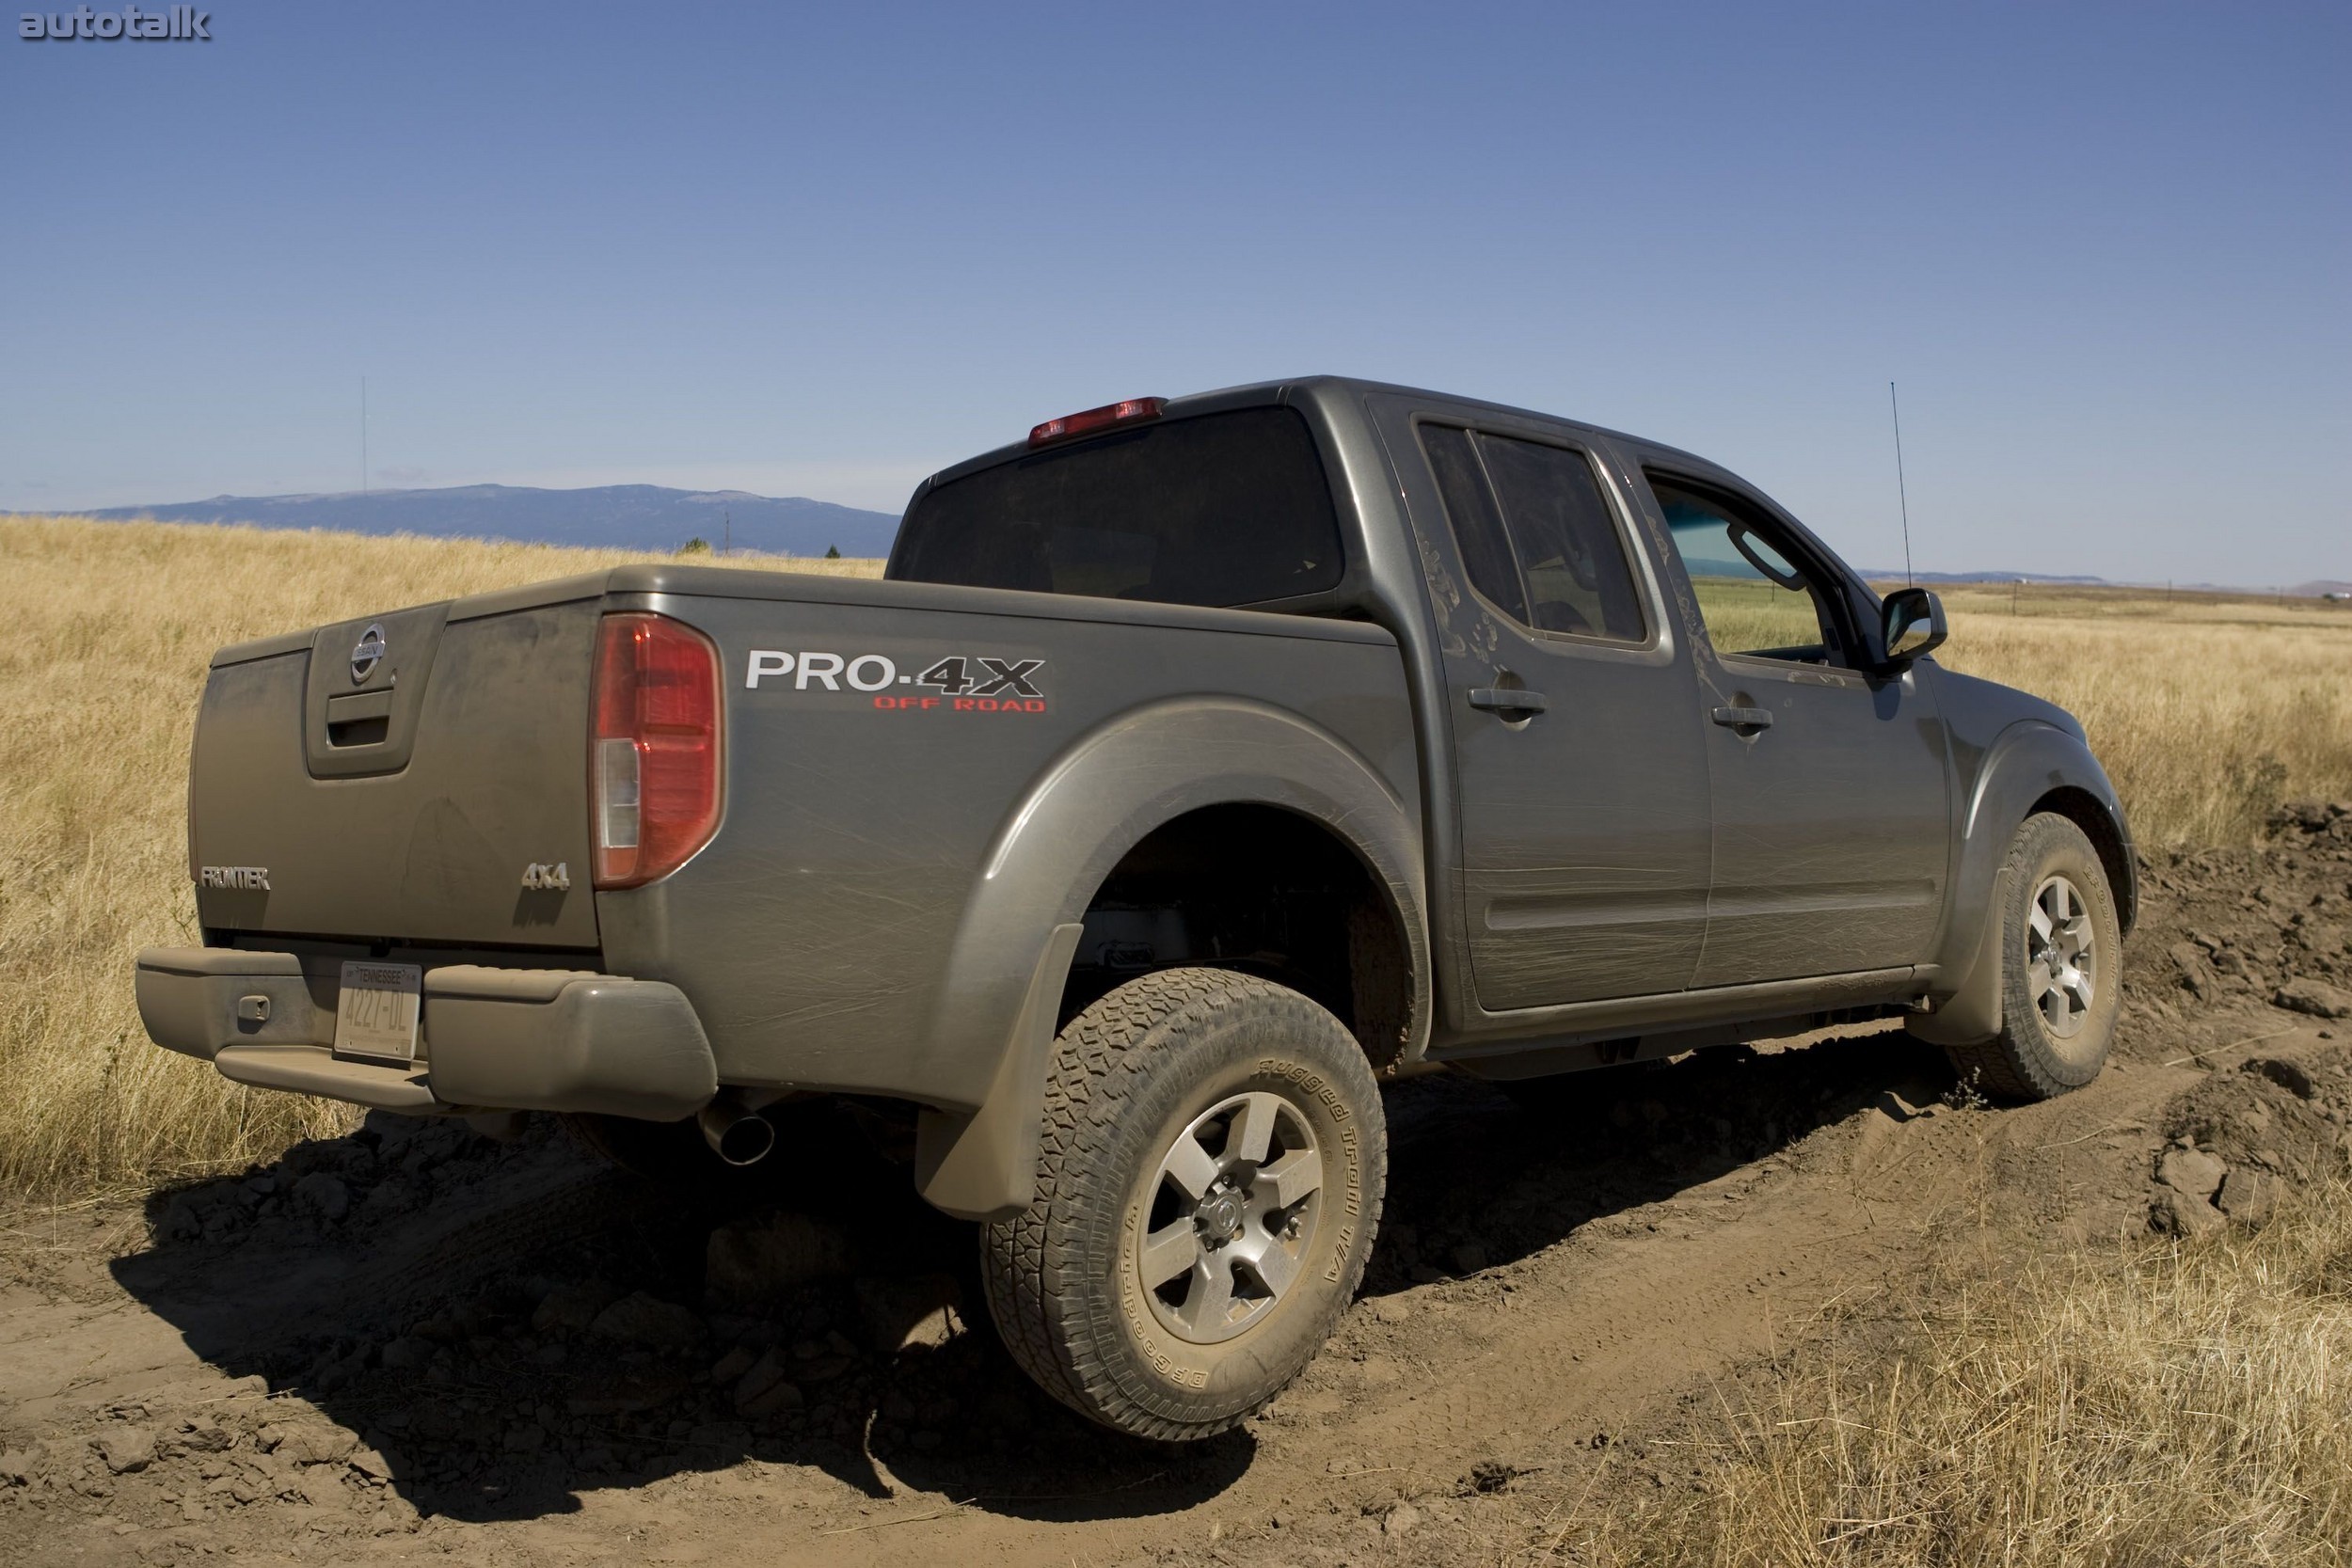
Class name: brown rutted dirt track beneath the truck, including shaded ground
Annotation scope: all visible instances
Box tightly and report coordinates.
[0,814,2352,1563]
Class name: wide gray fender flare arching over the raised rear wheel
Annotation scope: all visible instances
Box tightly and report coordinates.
[915,698,1430,1220]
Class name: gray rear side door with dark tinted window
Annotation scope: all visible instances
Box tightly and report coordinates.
[1391,404,1710,1011]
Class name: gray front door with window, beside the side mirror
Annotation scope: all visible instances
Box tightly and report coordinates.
[1649,467,1950,985]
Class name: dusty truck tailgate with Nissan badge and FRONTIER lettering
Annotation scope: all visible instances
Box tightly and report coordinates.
[188,594,600,950]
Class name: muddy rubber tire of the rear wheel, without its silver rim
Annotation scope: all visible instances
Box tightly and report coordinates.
[981,969,1388,1441]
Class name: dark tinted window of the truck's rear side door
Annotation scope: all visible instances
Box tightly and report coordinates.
[1421,425,1649,641]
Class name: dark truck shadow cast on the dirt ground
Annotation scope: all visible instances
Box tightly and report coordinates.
[116,1035,1952,1521]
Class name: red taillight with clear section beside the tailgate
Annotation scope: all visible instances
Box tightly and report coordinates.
[588,613,720,889]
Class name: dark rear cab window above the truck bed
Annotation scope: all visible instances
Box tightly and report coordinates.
[889,406,1343,607]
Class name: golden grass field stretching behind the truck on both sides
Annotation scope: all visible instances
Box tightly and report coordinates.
[0,517,2352,1195]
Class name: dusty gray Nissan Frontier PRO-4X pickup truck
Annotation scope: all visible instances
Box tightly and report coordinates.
[136,378,2134,1439]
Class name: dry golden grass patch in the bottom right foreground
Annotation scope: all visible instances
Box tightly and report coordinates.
[1529,1173,2352,1568]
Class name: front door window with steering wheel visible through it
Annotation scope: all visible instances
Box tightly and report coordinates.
[1649,472,1844,665]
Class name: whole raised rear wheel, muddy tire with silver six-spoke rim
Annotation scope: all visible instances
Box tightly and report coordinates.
[981,969,1388,1441]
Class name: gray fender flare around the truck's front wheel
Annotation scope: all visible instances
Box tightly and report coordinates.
[1903,720,2138,1046]
